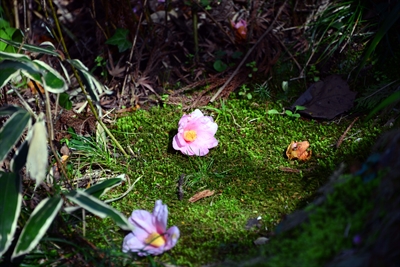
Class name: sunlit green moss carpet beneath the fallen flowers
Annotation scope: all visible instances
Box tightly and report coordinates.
[73,99,381,266]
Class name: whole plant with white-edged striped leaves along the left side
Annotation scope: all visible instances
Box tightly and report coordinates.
[0,39,131,261]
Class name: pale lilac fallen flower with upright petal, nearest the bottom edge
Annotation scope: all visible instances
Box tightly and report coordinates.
[122,200,180,256]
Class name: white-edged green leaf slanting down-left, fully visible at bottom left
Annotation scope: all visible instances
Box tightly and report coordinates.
[11,196,63,258]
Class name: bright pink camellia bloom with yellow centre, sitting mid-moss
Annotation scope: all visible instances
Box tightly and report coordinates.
[172,109,218,156]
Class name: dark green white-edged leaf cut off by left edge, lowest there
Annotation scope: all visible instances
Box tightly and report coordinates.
[0,172,22,257]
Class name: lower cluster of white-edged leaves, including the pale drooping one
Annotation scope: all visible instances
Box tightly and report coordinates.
[0,106,131,260]
